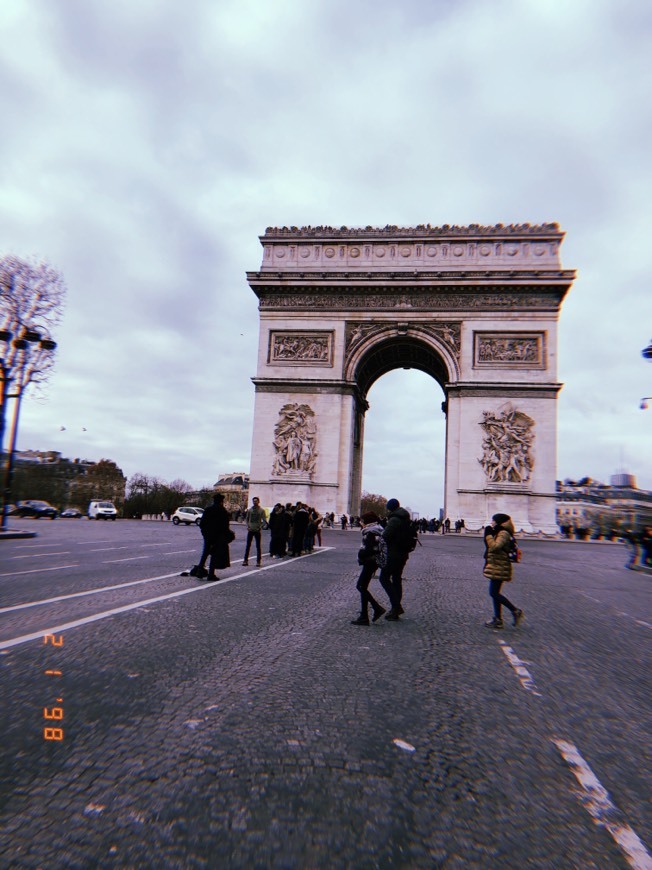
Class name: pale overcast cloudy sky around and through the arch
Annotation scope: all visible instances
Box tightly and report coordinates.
[0,0,652,516]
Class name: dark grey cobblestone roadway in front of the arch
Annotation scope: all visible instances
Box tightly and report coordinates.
[0,524,652,870]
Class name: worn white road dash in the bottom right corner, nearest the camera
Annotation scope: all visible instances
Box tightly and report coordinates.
[552,737,652,870]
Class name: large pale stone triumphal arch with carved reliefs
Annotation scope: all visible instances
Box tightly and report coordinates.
[247,224,575,533]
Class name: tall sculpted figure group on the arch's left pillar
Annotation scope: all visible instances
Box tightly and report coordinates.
[272,402,317,480]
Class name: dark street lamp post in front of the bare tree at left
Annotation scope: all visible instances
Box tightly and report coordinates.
[0,329,57,531]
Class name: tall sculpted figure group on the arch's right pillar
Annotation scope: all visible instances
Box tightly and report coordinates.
[478,402,534,484]
